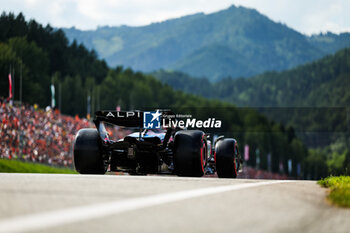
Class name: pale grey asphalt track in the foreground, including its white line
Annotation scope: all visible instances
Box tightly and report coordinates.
[0,173,350,233]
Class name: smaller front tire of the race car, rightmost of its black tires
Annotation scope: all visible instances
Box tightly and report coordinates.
[215,138,237,178]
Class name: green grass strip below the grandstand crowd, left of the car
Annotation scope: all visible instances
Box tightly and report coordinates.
[0,159,77,174]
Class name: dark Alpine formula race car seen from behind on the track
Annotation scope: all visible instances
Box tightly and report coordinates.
[73,110,242,178]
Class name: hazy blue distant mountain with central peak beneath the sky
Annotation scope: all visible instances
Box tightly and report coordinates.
[63,5,350,81]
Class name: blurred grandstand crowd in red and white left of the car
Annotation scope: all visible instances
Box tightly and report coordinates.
[0,99,92,167]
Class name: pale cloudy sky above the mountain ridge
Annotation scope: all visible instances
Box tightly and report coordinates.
[0,0,350,34]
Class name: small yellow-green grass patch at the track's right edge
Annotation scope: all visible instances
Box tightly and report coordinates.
[318,176,350,207]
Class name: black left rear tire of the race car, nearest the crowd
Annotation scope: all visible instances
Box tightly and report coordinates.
[73,129,106,174]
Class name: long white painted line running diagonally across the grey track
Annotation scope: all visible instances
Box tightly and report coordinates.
[0,180,289,233]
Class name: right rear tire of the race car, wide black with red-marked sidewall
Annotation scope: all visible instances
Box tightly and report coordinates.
[174,130,206,177]
